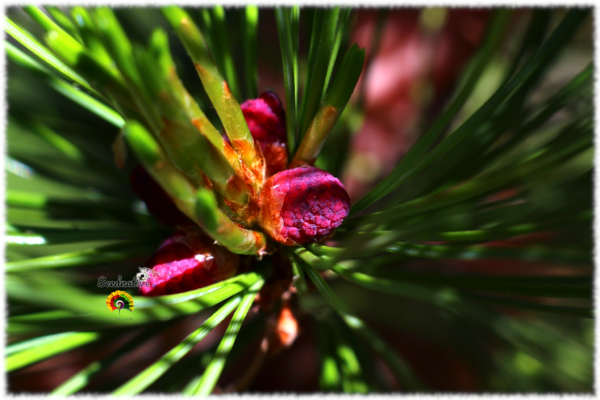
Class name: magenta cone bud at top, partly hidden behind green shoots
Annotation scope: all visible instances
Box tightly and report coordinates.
[241,91,287,177]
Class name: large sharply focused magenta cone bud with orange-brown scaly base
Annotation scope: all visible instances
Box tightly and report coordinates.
[259,166,350,246]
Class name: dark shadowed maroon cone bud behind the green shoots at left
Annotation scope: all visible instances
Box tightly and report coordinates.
[129,166,193,226]
